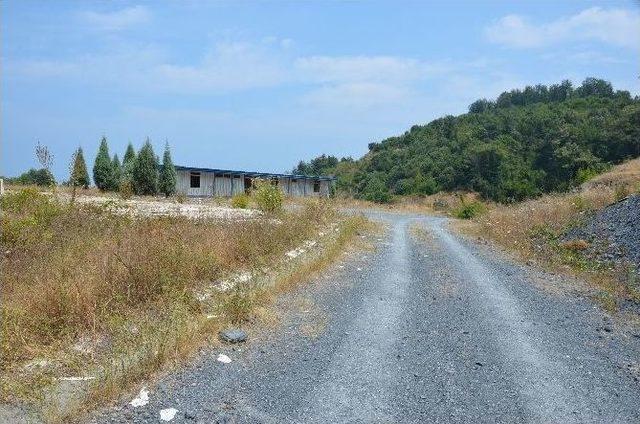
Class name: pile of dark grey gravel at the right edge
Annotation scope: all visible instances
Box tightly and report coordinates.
[565,194,640,270]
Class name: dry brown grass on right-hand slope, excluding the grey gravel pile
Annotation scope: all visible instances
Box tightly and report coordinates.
[462,159,640,308]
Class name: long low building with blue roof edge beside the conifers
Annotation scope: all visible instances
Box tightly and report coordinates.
[175,166,335,197]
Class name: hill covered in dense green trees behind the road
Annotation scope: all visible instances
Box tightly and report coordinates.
[293,78,640,202]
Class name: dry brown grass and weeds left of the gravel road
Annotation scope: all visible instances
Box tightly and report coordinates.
[0,189,363,421]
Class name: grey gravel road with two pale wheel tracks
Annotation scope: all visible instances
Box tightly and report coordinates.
[91,212,640,423]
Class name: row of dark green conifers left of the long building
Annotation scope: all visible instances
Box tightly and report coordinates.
[69,137,177,197]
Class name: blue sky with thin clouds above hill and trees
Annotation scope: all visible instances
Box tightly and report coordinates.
[0,0,640,179]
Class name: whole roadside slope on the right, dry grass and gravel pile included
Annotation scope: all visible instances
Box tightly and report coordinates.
[459,159,640,313]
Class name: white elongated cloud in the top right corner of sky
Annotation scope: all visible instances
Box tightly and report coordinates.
[485,7,640,49]
